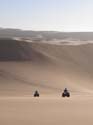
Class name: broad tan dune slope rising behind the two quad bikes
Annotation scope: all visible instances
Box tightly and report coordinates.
[0,40,93,96]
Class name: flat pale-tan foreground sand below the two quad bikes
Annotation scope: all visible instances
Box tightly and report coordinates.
[0,95,93,125]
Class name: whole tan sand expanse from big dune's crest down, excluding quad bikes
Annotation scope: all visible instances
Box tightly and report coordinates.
[0,40,93,125]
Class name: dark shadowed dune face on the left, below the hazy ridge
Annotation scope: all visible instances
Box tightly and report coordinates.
[0,38,50,61]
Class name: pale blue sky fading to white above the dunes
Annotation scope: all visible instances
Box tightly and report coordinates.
[0,0,93,32]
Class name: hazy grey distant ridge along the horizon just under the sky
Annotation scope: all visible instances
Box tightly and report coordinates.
[0,28,93,41]
